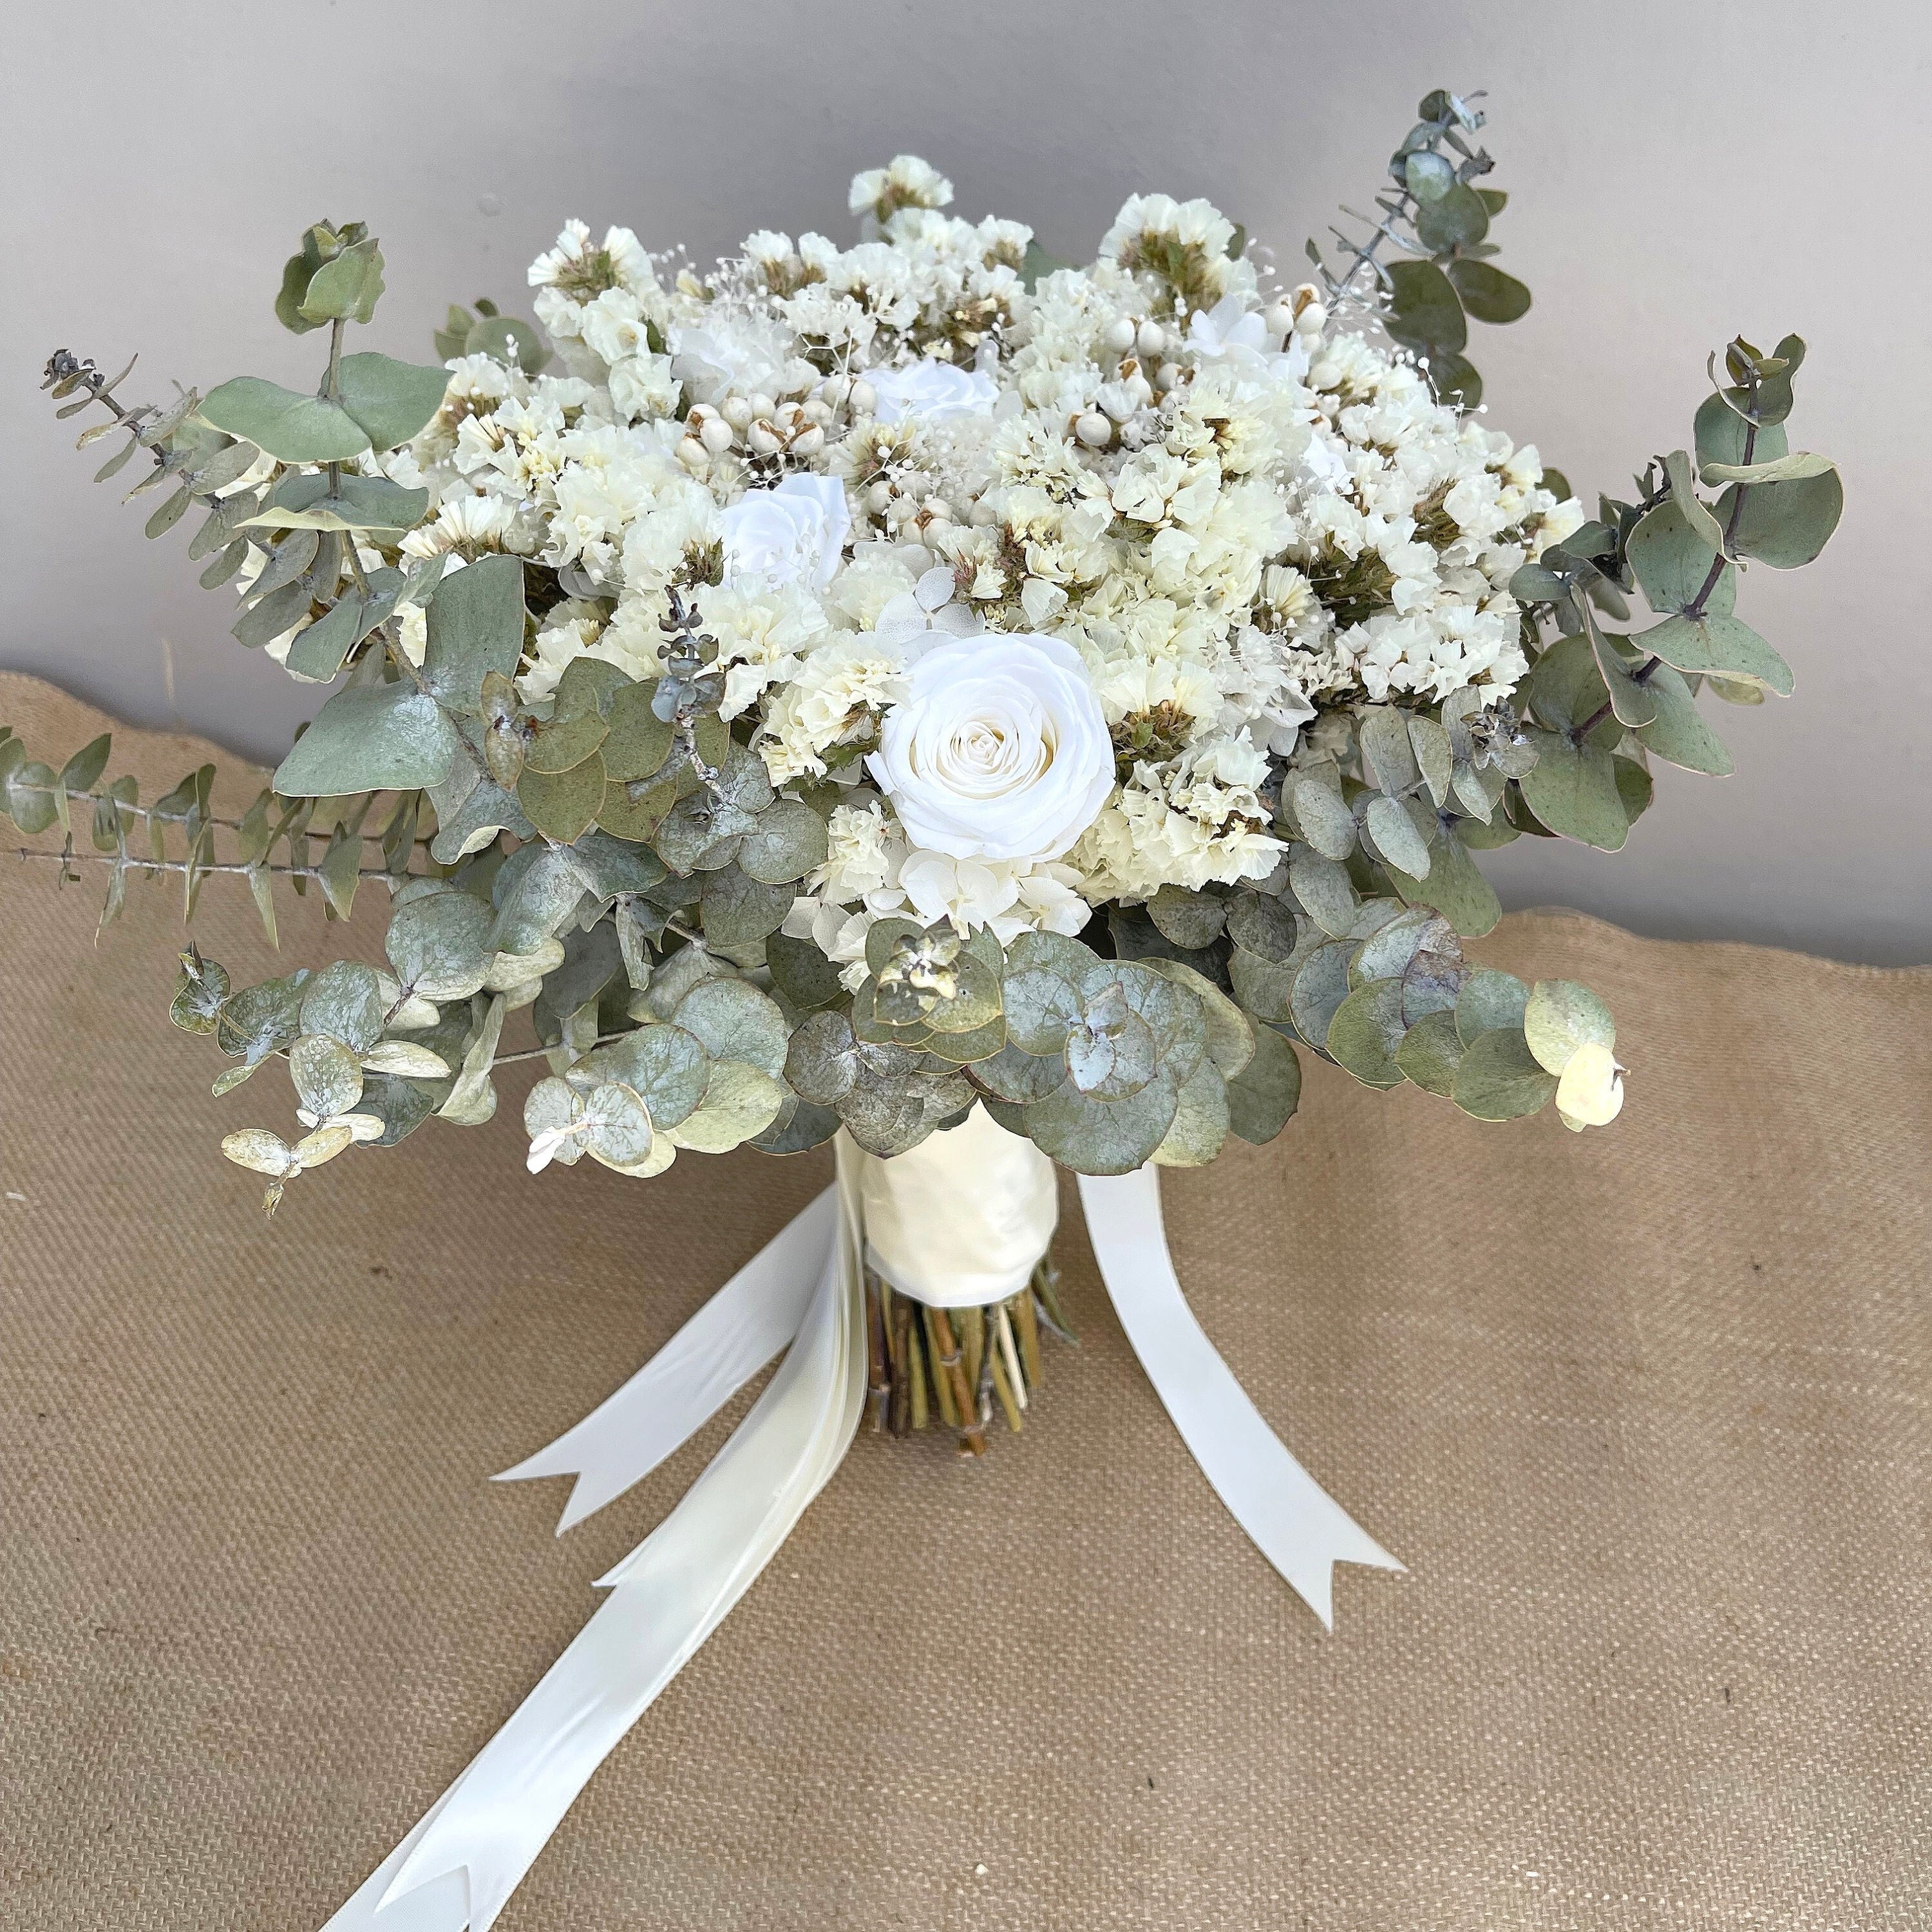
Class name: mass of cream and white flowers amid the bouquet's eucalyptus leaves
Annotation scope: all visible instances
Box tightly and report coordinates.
[386,156,1582,978]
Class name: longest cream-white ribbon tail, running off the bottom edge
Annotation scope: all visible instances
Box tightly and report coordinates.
[325,1194,866,1932]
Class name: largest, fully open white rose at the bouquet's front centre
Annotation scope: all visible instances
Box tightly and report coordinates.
[866,632,1113,860]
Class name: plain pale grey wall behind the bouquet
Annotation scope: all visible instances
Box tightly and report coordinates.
[0,0,1932,962]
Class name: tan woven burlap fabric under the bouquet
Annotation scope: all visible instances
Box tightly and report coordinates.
[0,678,1932,1932]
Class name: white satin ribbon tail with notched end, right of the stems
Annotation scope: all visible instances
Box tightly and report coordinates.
[1080,1167,1403,1629]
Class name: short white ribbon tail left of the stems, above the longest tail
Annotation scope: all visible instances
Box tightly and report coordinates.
[493,1188,838,1536]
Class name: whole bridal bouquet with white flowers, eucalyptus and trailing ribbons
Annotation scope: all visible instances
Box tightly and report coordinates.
[15,93,1841,1926]
